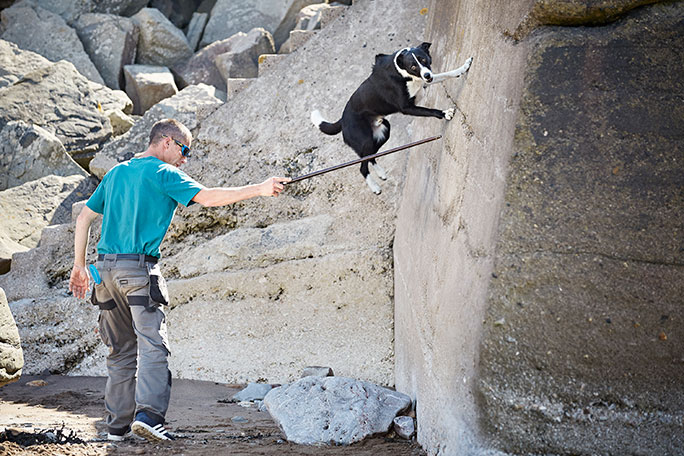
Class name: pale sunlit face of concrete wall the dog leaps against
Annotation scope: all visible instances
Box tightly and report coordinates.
[394,1,529,455]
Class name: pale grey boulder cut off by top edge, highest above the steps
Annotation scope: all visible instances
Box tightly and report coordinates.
[200,0,322,47]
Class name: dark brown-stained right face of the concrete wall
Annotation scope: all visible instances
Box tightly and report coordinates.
[481,3,684,454]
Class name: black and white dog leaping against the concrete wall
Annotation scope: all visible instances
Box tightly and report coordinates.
[311,43,473,194]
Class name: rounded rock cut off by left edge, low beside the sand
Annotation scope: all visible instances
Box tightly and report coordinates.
[0,288,24,387]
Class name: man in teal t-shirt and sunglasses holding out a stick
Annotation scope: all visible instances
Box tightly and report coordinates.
[69,119,289,441]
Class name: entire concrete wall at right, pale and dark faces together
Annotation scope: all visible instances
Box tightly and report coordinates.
[394,1,684,455]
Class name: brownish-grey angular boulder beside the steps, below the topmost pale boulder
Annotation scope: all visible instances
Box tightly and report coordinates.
[174,28,275,90]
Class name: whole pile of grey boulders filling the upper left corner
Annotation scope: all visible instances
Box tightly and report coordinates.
[0,0,350,282]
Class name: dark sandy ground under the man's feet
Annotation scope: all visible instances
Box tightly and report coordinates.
[0,376,425,456]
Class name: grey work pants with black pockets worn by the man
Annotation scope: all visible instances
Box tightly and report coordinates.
[94,255,171,434]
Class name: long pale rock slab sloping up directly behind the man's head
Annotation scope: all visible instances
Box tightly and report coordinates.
[90,84,223,179]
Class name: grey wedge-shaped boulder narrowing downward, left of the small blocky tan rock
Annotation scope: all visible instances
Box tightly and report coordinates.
[74,13,138,89]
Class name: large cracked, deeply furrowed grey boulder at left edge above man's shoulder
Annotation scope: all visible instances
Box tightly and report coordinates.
[0,61,112,158]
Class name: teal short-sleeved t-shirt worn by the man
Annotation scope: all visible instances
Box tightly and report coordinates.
[86,157,204,258]
